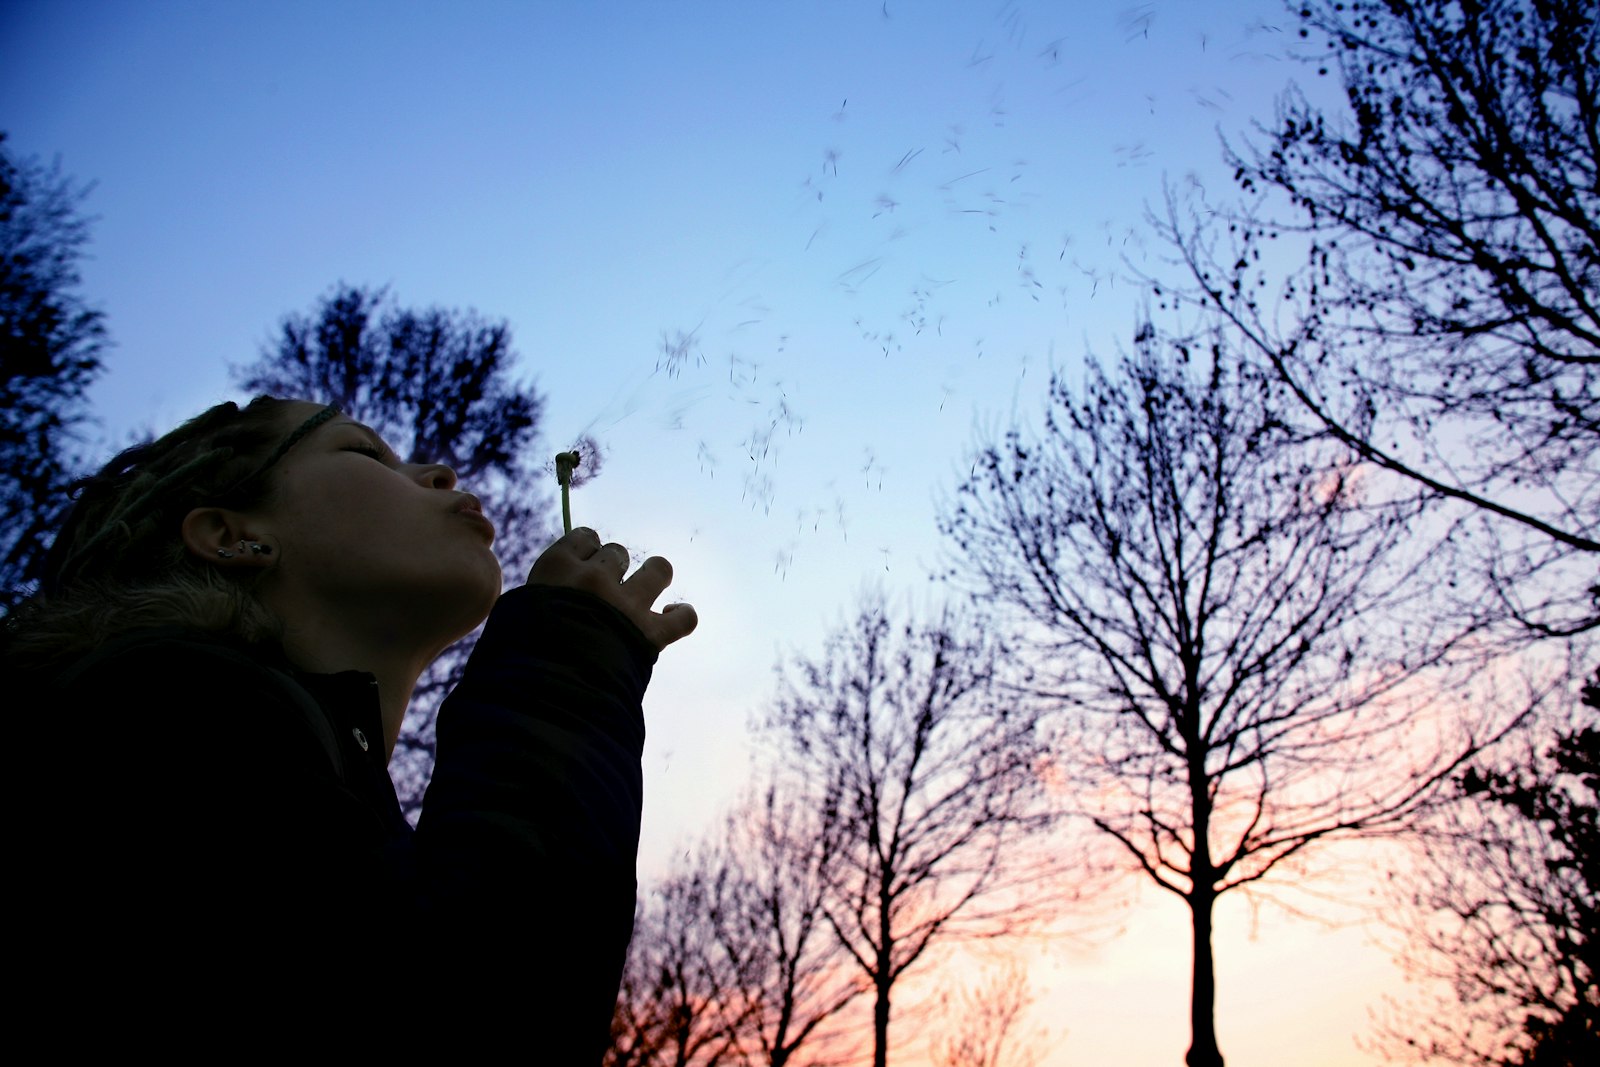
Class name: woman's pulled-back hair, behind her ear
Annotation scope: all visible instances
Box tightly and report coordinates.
[3,397,334,669]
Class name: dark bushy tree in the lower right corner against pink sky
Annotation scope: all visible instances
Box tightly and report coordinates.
[1384,672,1600,1067]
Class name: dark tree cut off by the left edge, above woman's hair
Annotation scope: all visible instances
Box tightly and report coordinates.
[0,134,106,617]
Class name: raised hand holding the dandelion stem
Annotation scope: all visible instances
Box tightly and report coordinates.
[528,526,699,651]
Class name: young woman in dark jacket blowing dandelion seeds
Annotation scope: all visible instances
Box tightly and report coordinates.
[3,397,696,1064]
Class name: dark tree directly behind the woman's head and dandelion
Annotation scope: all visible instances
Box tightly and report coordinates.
[235,285,554,813]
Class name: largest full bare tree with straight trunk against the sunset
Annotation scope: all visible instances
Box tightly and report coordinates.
[942,325,1504,1067]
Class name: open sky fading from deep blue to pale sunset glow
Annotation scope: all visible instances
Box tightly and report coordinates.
[0,0,1427,1067]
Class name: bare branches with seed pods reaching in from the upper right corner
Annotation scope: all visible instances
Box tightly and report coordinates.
[1163,0,1600,635]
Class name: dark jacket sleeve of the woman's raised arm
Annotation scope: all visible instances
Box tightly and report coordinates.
[418,585,656,1064]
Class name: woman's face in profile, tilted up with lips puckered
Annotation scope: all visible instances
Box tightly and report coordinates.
[254,402,501,651]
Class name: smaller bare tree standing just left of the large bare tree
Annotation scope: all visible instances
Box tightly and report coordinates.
[765,601,1048,1067]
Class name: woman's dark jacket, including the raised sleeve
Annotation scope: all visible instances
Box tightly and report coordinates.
[5,587,656,1064]
